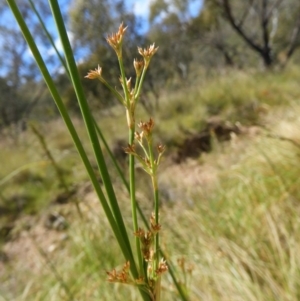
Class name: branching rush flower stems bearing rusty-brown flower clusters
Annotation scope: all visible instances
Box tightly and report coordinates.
[86,24,168,300]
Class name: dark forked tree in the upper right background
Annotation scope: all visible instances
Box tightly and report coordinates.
[205,0,300,68]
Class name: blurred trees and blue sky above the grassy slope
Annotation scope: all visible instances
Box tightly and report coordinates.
[0,0,300,130]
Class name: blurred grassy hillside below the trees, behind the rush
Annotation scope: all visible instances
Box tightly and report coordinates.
[0,67,300,301]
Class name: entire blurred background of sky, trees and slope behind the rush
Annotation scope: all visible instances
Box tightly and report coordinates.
[0,0,300,301]
